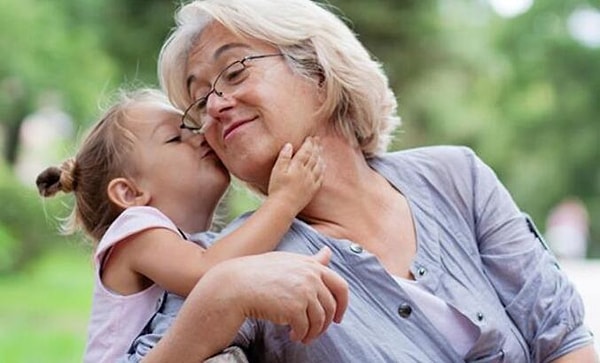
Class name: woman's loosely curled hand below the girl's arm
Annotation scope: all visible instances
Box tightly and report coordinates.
[231,248,348,343]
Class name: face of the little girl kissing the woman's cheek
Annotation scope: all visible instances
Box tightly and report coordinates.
[130,104,230,215]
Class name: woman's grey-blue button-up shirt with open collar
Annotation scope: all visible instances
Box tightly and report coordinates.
[122,146,592,362]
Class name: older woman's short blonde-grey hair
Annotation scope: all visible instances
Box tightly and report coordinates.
[158,0,400,157]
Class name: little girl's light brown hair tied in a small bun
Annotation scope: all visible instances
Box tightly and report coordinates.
[36,89,181,243]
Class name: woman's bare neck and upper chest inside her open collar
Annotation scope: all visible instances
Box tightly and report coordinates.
[299,137,417,278]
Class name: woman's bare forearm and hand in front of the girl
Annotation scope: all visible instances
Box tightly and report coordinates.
[143,248,348,363]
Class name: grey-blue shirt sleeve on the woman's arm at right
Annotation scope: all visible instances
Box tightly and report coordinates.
[467,148,592,361]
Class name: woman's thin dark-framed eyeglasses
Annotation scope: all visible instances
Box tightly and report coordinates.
[179,53,283,133]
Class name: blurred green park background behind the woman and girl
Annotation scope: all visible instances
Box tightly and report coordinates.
[0,0,600,362]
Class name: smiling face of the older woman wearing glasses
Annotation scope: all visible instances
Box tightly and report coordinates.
[187,23,325,192]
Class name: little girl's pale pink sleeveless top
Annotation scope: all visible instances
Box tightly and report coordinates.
[83,207,179,363]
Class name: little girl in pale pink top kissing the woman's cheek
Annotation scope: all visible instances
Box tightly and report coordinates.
[36,89,323,363]
